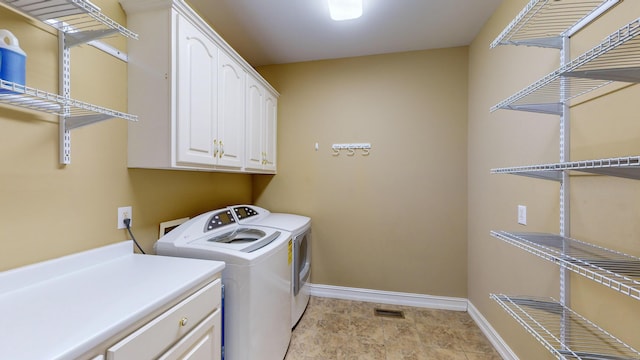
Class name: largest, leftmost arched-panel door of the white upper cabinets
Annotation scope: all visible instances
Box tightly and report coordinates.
[175,16,218,165]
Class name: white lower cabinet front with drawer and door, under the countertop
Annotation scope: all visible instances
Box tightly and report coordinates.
[106,279,222,360]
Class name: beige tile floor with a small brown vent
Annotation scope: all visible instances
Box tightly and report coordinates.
[285,297,501,360]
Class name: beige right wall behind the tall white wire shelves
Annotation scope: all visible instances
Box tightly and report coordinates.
[468,0,640,359]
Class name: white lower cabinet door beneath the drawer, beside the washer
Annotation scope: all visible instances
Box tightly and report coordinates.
[159,309,222,360]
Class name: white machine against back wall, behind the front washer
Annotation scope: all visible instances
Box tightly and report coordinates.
[231,205,311,328]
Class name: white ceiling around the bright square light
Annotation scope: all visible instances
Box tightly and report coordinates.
[187,0,502,66]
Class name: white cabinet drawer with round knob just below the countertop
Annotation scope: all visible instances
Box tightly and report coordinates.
[107,279,221,360]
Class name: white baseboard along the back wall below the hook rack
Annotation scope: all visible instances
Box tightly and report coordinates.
[309,284,467,311]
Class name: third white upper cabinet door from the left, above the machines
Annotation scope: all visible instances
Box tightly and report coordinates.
[245,77,265,170]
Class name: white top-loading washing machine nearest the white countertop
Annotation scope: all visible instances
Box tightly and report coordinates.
[155,208,292,360]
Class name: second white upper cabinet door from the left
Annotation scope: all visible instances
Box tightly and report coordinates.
[217,51,246,168]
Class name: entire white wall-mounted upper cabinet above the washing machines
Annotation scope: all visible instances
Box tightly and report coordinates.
[121,0,278,173]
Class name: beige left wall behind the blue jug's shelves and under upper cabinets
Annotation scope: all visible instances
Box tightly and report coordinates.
[0,0,251,270]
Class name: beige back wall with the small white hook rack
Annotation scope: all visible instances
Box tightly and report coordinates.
[254,47,467,297]
